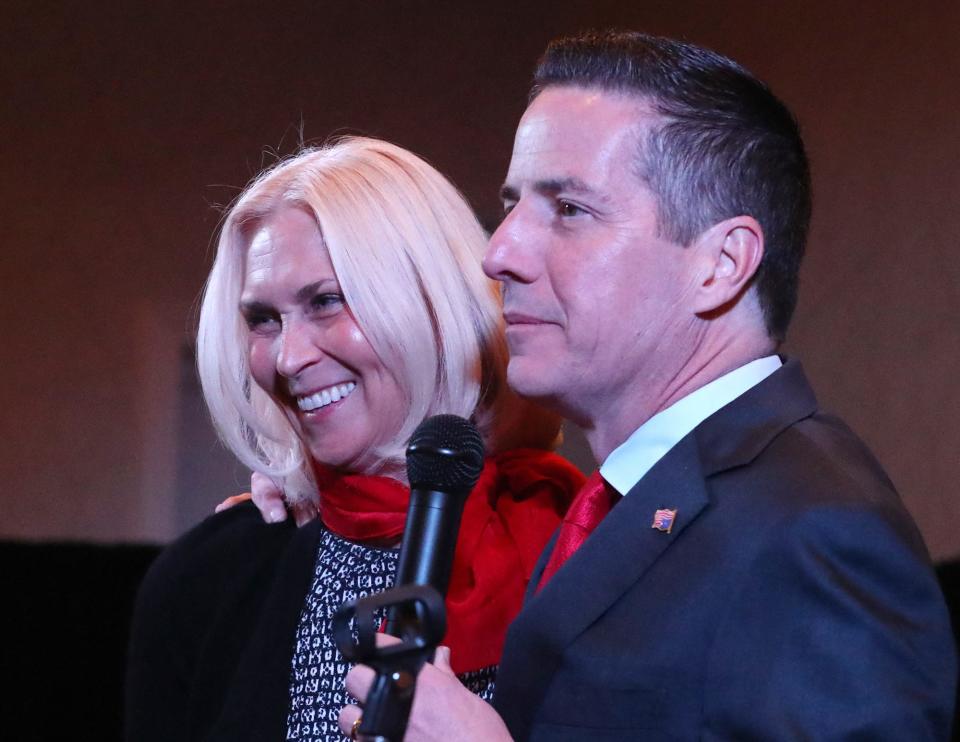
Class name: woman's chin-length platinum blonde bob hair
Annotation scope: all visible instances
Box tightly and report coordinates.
[197,137,540,502]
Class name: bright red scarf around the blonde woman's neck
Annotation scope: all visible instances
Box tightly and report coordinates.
[316,448,583,673]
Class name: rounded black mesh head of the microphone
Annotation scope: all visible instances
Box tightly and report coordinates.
[407,415,483,492]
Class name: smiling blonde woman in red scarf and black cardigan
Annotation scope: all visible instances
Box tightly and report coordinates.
[127,138,582,742]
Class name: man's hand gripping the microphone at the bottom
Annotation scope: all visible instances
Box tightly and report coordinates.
[340,634,512,742]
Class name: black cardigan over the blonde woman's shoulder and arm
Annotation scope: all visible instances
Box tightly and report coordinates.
[124,503,322,742]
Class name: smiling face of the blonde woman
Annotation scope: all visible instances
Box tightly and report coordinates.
[240,207,407,471]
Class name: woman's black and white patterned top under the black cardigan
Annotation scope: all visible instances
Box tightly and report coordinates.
[287,531,496,742]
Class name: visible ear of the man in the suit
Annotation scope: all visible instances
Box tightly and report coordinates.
[692,216,764,314]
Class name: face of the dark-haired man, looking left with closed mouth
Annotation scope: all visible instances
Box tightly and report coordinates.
[484,87,698,427]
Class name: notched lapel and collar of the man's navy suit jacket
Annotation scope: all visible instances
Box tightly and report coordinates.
[494,361,816,739]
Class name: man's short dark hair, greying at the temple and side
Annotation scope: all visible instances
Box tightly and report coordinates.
[531,31,811,341]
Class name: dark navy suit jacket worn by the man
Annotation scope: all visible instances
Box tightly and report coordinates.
[494,362,957,742]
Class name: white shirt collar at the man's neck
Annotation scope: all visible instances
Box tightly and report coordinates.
[600,356,783,495]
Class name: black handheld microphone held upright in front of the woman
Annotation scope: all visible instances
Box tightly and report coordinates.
[386,415,484,635]
